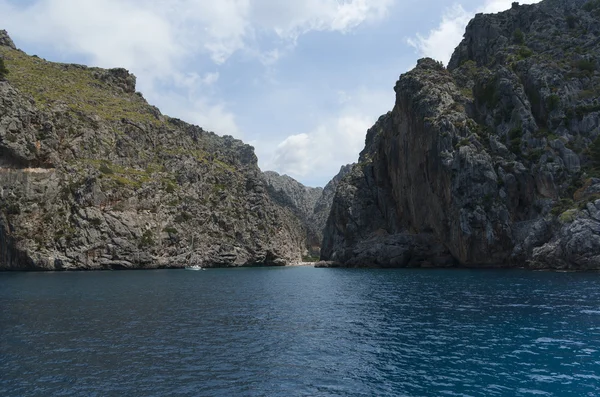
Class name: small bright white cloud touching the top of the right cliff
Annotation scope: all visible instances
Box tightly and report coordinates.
[407,0,540,64]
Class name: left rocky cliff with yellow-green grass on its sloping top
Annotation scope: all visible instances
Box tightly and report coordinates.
[0,32,305,270]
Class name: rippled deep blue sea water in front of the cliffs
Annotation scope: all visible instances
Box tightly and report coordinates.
[0,267,600,397]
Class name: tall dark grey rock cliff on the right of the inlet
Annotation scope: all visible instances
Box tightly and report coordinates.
[322,0,600,269]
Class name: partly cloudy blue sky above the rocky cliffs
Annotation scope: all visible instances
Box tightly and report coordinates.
[0,0,538,187]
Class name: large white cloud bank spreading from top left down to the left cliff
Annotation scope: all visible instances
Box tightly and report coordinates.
[0,0,395,155]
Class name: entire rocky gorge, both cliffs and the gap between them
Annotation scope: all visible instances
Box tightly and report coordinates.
[0,0,600,270]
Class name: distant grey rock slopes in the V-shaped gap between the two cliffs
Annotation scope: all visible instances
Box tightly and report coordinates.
[264,165,351,258]
